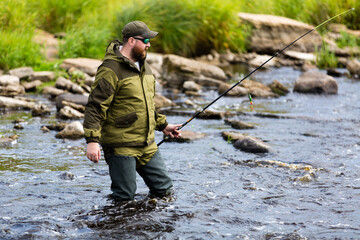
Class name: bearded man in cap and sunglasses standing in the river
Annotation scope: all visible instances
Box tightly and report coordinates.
[84,21,181,200]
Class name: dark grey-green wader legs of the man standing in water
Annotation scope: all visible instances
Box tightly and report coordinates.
[105,151,172,200]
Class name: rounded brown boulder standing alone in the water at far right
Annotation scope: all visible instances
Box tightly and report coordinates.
[294,71,338,94]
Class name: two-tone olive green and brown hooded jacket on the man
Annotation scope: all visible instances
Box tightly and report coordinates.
[84,40,167,147]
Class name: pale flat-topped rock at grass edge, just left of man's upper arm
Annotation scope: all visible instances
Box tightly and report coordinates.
[60,58,102,76]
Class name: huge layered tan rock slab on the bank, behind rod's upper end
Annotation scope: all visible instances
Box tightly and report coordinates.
[238,13,322,54]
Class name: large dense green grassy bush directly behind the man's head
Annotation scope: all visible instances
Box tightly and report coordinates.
[115,0,249,56]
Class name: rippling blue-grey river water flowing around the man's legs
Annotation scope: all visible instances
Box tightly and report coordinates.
[0,68,360,239]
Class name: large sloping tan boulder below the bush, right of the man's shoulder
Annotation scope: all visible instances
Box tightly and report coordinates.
[163,54,227,89]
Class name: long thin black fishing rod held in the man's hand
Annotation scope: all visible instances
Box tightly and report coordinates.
[158,8,355,146]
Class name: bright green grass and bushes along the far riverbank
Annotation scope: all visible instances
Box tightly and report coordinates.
[0,0,360,70]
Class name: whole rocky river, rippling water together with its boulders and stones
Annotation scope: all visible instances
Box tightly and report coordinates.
[0,13,360,239]
